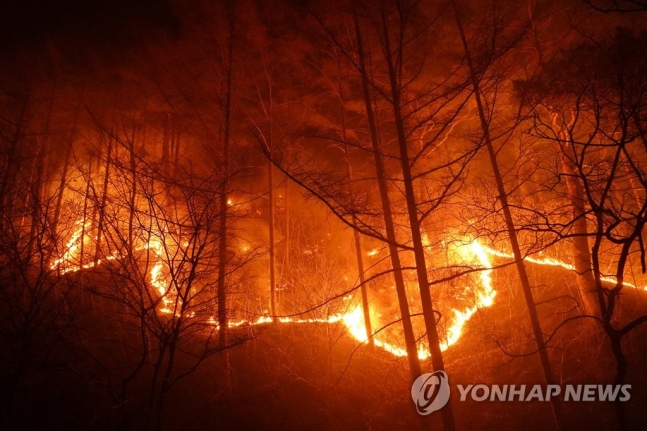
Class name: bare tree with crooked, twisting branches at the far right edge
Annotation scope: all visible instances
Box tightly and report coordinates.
[535,29,647,429]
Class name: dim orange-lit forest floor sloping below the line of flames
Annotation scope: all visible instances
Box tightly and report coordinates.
[163,264,647,431]
